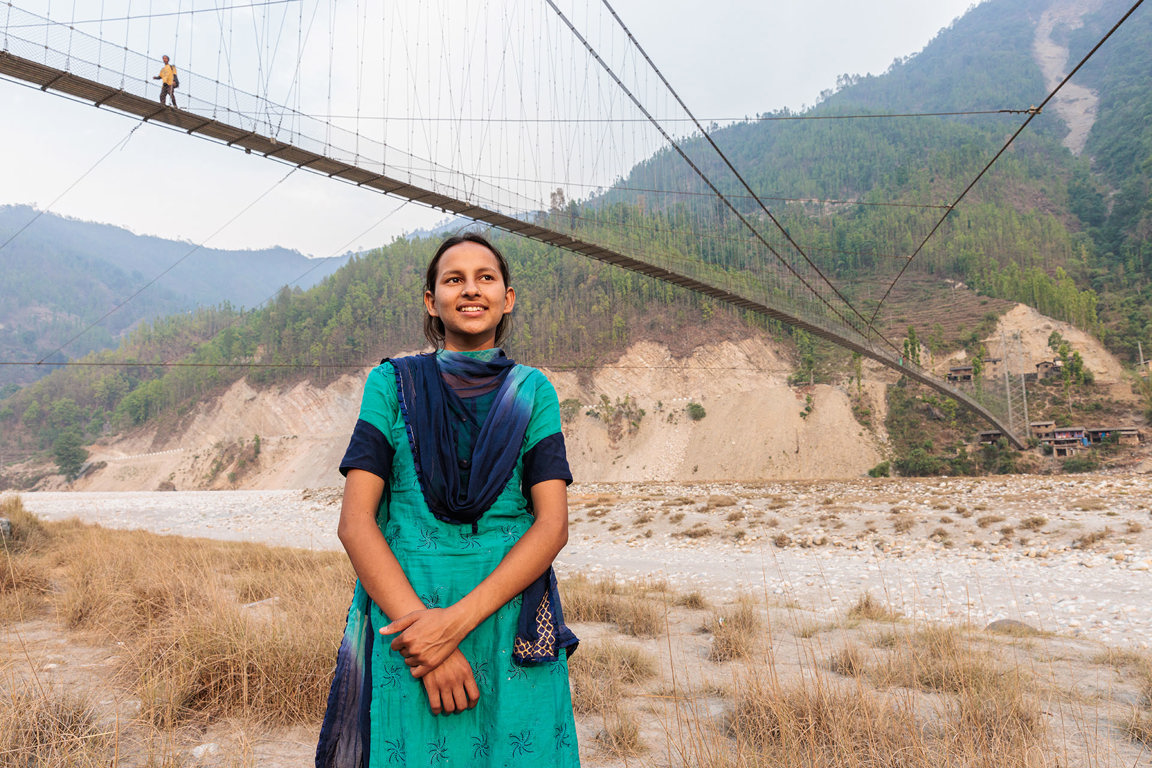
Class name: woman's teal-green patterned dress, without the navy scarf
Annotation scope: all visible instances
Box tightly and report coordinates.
[359,363,579,768]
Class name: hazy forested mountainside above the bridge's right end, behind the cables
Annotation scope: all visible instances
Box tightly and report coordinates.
[622,0,1152,362]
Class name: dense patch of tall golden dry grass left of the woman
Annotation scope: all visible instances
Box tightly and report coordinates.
[0,502,355,728]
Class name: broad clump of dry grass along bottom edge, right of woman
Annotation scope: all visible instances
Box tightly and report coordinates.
[694,632,1051,768]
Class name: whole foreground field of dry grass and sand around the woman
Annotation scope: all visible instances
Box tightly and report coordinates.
[0,499,1152,768]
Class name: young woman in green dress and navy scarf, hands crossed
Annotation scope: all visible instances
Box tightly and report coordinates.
[316,234,579,768]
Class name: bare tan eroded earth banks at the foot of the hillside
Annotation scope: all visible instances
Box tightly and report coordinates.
[67,305,1135,491]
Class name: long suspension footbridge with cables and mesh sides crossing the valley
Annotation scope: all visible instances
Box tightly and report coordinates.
[0,0,1046,448]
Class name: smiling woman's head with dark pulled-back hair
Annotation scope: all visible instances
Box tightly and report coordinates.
[424,242,516,352]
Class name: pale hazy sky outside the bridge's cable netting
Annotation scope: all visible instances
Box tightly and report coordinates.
[0,0,972,257]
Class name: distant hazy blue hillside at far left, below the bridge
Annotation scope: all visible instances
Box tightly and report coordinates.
[0,206,347,395]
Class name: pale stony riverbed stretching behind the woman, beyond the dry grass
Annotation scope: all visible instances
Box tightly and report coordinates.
[15,474,1152,647]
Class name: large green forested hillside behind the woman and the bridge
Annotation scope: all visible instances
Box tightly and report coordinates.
[0,0,1152,474]
